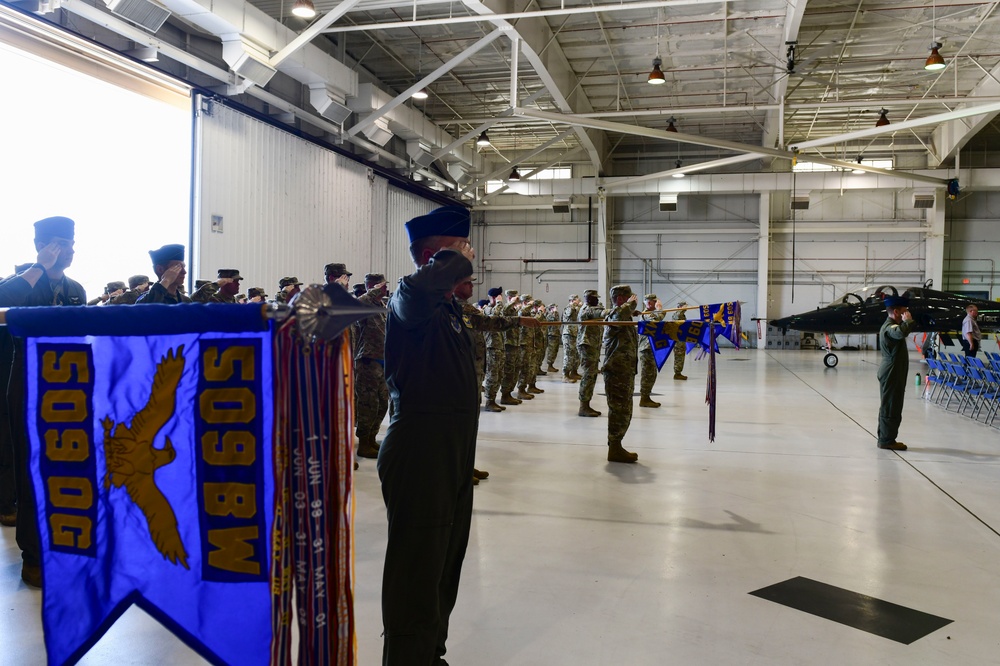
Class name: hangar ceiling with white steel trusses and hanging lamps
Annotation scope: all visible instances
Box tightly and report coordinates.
[11,0,1000,197]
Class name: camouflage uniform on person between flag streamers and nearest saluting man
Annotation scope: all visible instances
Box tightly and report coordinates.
[351,282,389,458]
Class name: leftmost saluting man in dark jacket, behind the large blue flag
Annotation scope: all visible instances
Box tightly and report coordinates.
[0,217,87,587]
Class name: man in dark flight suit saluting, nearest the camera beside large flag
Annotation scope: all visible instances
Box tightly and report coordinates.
[378,206,479,665]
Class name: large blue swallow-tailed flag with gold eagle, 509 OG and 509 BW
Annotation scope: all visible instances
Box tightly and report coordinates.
[8,305,274,665]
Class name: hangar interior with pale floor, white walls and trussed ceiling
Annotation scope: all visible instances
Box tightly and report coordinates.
[0,0,1000,664]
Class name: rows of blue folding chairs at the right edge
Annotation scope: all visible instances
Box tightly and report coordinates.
[924,355,1000,428]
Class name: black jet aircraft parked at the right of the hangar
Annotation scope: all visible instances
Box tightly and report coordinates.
[768,281,1000,368]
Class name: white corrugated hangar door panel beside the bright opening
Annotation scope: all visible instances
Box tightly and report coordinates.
[190,100,437,295]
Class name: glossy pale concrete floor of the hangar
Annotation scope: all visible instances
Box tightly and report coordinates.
[0,350,1000,666]
